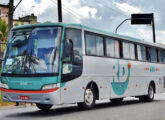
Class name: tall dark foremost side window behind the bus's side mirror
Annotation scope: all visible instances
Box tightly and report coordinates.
[62,28,83,82]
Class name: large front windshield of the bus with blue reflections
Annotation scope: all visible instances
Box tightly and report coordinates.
[2,27,61,74]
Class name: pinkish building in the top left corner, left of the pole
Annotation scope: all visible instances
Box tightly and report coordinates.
[0,4,9,24]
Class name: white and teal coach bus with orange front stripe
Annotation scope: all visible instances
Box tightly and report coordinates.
[0,23,165,110]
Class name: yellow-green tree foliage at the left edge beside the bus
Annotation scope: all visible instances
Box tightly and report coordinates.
[0,18,8,51]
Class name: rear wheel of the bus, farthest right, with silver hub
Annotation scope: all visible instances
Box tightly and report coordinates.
[139,83,155,102]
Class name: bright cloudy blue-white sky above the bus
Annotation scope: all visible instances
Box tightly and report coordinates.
[0,0,165,44]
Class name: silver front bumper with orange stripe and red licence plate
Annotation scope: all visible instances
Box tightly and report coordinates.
[0,88,60,104]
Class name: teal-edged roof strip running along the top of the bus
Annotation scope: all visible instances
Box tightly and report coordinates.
[12,23,165,48]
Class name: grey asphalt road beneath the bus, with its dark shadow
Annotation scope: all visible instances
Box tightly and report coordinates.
[0,94,165,120]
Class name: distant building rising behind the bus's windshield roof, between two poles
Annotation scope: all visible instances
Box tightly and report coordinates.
[13,14,37,26]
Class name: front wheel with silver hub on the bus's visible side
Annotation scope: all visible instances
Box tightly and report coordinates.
[78,88,96,110]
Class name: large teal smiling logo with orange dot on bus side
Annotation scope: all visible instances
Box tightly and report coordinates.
[111,60,131,95]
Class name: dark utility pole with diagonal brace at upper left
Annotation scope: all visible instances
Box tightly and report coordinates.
[8,0,22,30]
